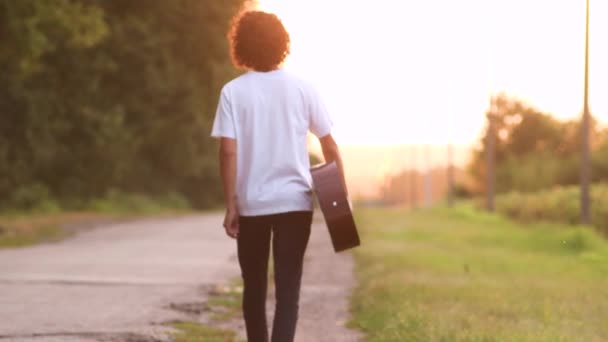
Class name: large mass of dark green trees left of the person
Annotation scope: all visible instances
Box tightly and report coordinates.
[0,0,243,209]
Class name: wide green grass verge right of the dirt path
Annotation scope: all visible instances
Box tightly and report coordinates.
[351,207,608,341]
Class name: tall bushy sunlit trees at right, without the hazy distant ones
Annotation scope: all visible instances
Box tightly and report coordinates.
[469,94,608,193]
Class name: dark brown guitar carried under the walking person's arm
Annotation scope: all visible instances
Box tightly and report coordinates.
[310,162,361,252]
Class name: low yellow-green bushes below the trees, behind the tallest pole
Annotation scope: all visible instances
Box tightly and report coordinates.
[496,183,608,234]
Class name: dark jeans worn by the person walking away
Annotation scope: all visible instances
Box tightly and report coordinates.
[237,211,312,342]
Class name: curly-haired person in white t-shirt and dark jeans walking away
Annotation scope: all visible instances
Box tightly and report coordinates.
[212,11,343,342]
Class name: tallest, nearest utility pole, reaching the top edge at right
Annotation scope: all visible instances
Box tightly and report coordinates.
[581,0,591,224]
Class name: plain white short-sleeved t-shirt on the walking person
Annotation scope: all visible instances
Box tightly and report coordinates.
[211,69,332,216]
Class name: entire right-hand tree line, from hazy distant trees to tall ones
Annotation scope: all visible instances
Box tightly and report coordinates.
[380,94,608,203]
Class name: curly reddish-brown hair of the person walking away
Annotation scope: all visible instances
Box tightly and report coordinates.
[228,10,291,72]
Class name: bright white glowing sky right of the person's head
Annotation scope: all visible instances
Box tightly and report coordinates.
[261,0,608,144]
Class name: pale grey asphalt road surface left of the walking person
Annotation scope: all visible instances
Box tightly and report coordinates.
[0,215,239,341]
